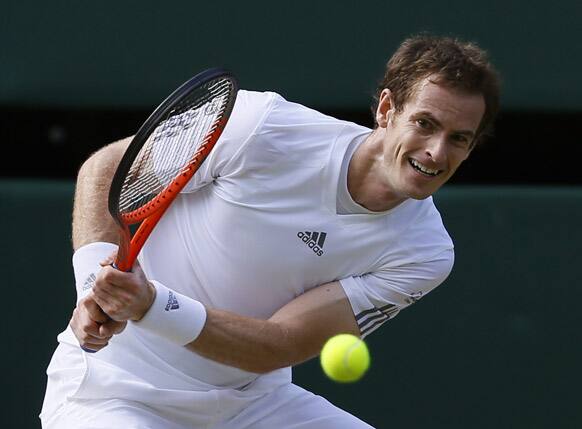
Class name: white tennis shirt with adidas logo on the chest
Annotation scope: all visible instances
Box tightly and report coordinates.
[56,90,453,407]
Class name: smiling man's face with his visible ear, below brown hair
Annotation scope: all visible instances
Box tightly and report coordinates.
[376,78,485,199]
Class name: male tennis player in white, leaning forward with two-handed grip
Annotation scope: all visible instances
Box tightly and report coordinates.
[41,36,498,429]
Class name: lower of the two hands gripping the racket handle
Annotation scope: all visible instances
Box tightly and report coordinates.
[69,293,127,352]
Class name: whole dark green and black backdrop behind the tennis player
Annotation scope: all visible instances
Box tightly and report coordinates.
[0,0,582,429]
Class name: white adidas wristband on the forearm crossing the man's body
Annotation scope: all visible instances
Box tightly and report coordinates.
[133,280,206,346]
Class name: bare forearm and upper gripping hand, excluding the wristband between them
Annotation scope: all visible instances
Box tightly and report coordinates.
[93,264,360,373]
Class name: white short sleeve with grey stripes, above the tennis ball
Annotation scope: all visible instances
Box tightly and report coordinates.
[340,249,454,337]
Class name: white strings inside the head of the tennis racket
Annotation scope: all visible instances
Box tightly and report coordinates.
[119,78,234,213]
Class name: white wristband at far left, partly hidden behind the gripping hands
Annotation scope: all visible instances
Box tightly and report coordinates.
[73,242,117,303]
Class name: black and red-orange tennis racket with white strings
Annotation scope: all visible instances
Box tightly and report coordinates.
[109,69,238,271]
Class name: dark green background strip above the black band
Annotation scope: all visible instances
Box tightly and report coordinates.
[0,0,582,109]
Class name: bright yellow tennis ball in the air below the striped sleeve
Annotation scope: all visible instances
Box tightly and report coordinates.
[319,334,370,383]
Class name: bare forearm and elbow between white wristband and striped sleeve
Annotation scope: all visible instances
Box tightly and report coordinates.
[186,282,360,373]
